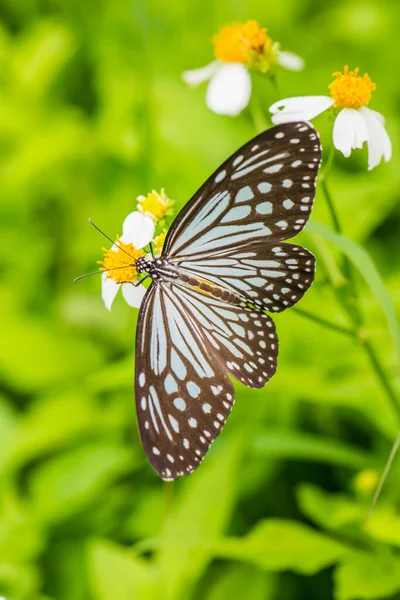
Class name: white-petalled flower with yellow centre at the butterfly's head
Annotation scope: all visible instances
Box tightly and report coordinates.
[101,211,155,310]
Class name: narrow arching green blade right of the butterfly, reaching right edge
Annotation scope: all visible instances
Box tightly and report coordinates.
[307,219,400,359]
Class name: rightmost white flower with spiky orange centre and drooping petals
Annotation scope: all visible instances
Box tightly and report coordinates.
[269,67,392,170]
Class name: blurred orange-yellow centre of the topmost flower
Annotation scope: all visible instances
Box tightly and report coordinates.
[212,21,269,64]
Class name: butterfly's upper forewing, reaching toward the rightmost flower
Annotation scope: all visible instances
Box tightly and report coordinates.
[163,123,321,258]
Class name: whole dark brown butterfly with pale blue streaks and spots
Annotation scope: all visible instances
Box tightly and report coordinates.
[135,122,321,481]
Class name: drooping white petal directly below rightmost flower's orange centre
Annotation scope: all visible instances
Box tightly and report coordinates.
[333,108,368,157]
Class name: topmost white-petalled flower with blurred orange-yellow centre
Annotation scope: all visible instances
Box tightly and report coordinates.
[182,21,304,117]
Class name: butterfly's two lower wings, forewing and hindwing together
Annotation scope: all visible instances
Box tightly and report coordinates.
[135,282,278,480]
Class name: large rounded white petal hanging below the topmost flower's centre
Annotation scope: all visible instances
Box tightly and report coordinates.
[206,63,251,117]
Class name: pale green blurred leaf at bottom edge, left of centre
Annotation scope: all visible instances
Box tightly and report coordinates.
[87,540,157,600]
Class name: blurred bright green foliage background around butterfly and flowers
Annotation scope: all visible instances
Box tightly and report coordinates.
[0,0,400,600]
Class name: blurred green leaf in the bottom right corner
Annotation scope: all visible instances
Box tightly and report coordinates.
[335,552,400,600]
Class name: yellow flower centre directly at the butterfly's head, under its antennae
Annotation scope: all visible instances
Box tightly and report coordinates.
[98,237,144,283]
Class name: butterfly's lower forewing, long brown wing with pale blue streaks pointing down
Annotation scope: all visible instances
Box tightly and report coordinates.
[135,283,233,480]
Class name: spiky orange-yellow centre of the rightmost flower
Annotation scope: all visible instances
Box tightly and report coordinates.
[328,66,376,108]
